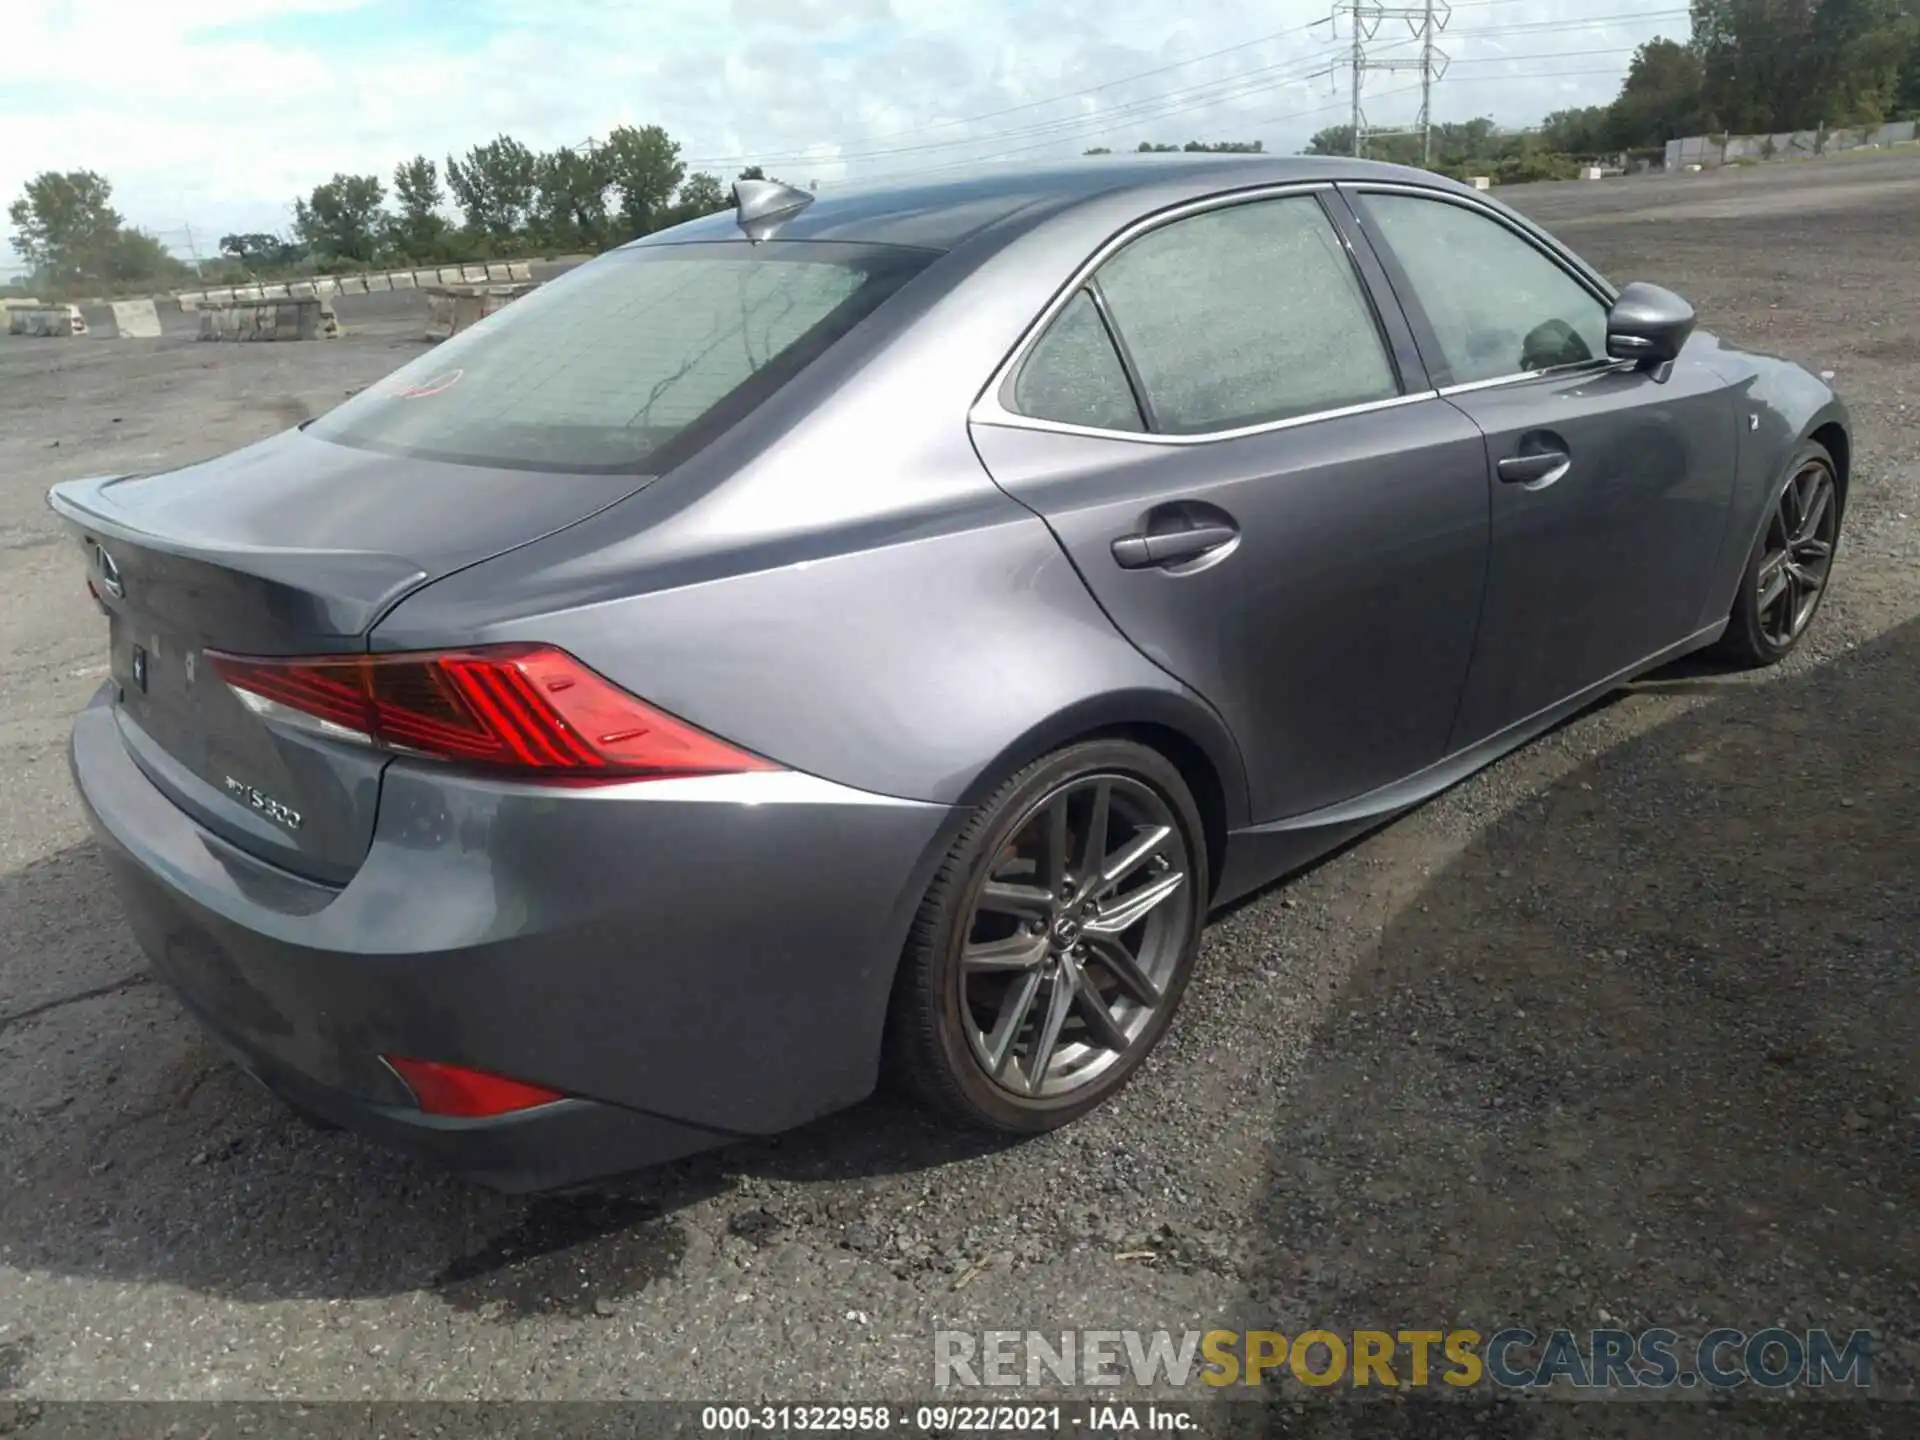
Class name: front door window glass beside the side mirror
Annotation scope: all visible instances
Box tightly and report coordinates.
[1361,194,1607,384]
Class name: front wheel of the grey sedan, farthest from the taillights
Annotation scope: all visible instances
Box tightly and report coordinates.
[1722,445,1839,668]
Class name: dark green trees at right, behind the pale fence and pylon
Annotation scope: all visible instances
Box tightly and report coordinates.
[1308,0,1920,182]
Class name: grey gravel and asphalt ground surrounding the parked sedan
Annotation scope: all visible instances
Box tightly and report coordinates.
[0,152,1920,1436]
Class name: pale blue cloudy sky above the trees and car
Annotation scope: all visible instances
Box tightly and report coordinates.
[0,0,1686,257]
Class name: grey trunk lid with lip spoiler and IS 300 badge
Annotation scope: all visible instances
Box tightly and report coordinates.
[48,430,645,883]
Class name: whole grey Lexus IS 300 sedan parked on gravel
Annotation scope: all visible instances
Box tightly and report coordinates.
[50,156,1853,1190]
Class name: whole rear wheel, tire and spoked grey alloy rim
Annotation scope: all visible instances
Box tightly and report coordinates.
[889,741,1208,1133]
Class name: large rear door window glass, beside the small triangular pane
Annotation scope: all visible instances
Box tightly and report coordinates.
[1098,196,1400,436]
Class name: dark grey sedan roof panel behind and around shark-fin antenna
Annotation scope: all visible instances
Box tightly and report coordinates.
[634,154,1465,250]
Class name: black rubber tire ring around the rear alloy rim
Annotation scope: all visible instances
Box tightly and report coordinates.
[927,739,1210,1133]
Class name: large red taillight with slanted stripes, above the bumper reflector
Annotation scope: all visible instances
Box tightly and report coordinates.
[207,645,778,781]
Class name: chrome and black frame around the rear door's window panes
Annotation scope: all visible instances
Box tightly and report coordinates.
[968,180,1440,445]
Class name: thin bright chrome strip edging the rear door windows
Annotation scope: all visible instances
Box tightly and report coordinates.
[968,180,1440,445]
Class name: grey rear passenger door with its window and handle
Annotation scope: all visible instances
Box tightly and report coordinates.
[973,186,1488,822]
